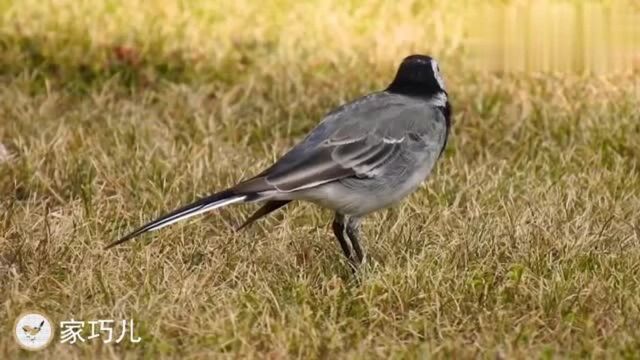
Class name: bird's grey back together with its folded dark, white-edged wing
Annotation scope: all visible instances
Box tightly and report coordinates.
[241,93,439,192]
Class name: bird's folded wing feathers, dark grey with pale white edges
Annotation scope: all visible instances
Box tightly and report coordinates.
[262,134,404,192]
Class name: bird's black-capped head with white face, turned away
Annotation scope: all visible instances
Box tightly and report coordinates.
[387,55,446,97]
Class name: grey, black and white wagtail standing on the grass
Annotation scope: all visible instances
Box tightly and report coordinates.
[106,55,451,269]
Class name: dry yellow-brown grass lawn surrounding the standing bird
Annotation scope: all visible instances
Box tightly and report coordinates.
[0,0,640,358]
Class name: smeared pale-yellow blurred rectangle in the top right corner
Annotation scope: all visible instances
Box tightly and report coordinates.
[465,0,640,75]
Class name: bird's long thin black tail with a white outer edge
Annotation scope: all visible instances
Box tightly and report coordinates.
[105,189,246,249]
